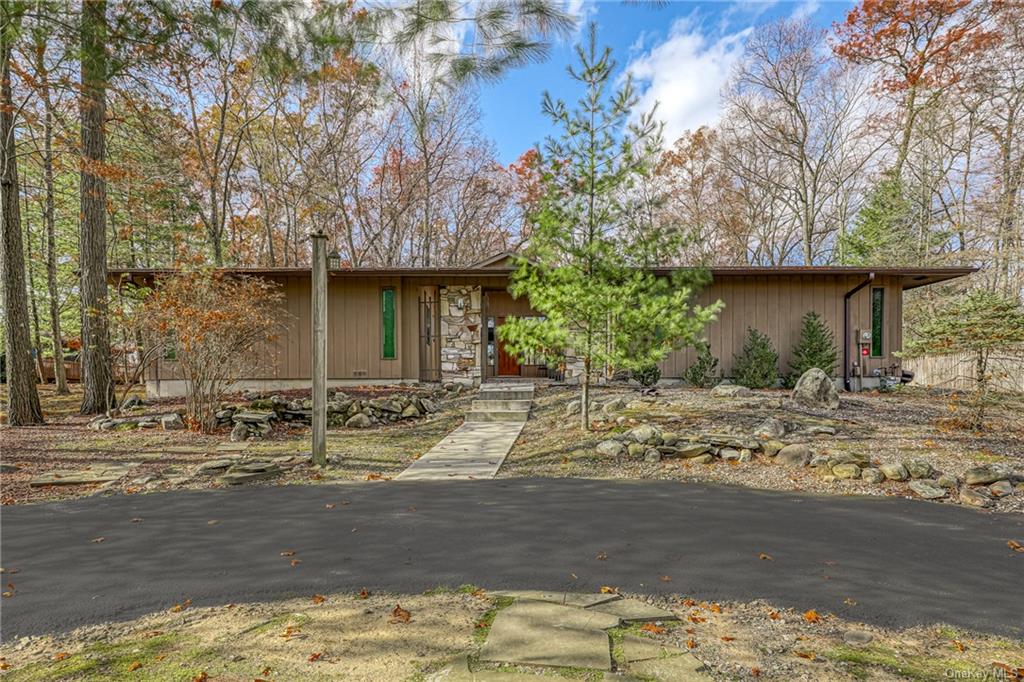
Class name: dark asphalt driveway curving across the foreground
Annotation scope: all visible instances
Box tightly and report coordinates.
[0,479,1024,640]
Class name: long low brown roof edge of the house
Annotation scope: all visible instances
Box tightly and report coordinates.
[108,261,978,289]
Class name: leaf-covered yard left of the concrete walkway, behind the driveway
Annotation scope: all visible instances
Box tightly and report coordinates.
[0,386,468,505]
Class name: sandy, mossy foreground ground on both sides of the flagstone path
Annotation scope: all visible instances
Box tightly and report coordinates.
[0,586,1024,682]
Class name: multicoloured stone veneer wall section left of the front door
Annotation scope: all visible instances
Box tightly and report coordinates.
[440,287,483,384]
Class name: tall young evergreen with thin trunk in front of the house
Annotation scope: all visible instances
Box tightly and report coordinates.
[499,25,720,429]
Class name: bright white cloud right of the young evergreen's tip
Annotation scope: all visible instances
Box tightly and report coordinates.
[626,16,752,144]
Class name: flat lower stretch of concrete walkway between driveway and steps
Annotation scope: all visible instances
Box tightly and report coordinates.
[395,422,523,480]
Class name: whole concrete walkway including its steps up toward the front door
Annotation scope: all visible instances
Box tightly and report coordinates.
[395,384,534,480]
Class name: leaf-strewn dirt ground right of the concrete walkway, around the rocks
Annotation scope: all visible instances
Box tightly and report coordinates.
[498,387,1024,513]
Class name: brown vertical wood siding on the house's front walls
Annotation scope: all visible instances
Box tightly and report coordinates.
[151,273,902,380]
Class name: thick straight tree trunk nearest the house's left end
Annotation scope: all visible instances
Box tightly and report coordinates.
[79,0,114,415]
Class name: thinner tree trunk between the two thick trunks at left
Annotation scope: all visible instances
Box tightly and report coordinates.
[36,31,69,395]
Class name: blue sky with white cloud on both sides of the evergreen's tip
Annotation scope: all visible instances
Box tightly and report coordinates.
[480,0,853,164]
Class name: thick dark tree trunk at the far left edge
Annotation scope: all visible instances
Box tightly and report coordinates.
[0,15,43,426]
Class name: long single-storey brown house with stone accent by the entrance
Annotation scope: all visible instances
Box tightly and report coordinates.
[111,254,974,396]
